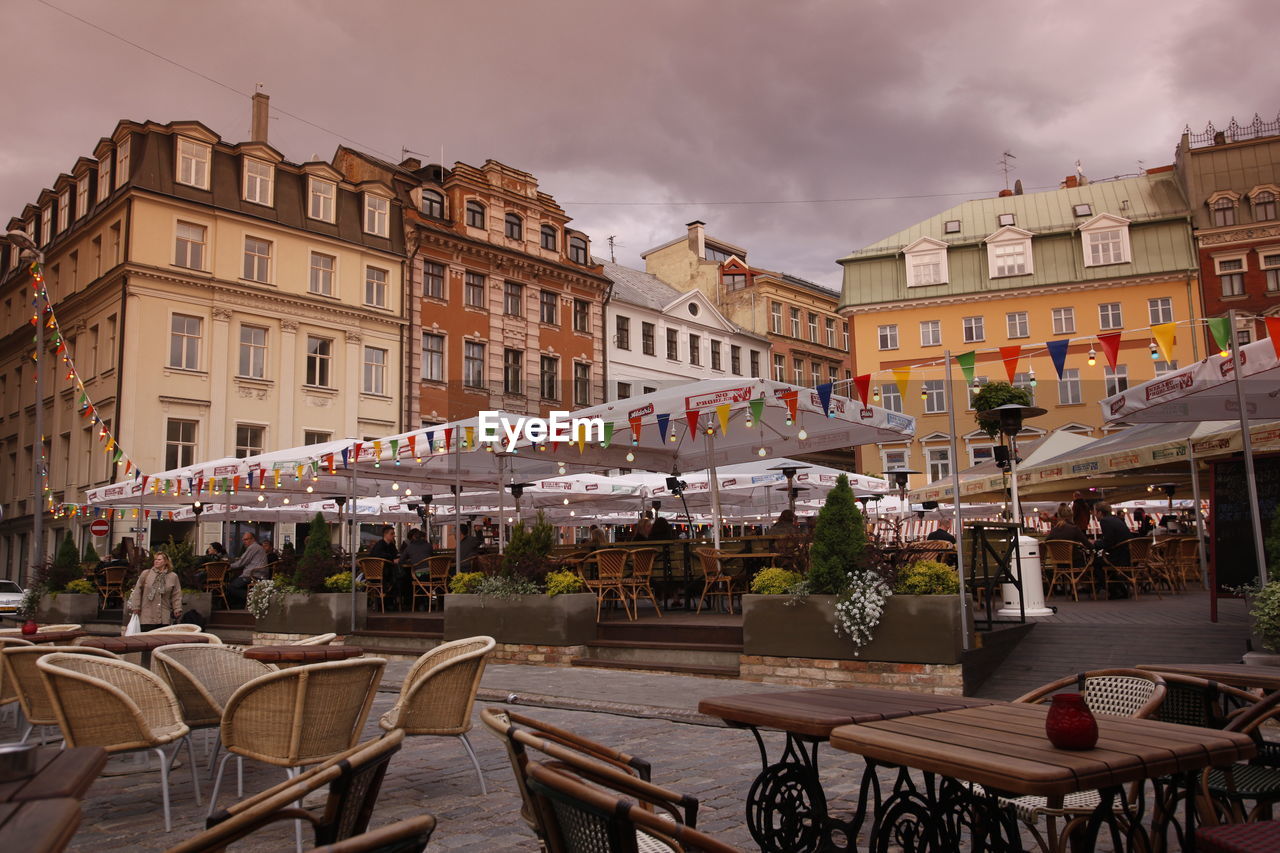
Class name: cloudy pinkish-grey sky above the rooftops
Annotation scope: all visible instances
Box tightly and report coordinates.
[0,0,1280,288]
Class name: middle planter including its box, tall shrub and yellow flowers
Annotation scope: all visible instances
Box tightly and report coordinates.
[444,512,595,646]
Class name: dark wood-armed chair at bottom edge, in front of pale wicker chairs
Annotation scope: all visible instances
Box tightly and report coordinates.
[166,731,404,853]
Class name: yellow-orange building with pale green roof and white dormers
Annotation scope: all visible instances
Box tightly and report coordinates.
[840,169,1206,487]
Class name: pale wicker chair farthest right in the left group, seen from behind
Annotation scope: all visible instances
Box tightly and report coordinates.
[378,637,495,794]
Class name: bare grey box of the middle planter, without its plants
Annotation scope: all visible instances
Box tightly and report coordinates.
[444,593,595,646]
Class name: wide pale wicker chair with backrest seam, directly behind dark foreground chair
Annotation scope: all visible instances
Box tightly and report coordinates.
[209,657,387,814]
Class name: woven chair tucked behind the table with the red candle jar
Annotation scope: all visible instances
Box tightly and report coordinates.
[1000,670,1166,853]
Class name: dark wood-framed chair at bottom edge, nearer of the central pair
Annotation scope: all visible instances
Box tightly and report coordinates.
[527,761,737,853]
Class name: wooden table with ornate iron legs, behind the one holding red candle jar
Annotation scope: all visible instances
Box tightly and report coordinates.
[698,688,991,853]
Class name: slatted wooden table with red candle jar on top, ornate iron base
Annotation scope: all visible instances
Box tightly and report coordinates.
[831,703,1256,850]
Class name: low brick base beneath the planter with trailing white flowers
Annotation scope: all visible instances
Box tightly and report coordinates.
[739,654,964,695]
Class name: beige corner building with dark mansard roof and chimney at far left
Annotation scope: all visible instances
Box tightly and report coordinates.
[0,95,406,576]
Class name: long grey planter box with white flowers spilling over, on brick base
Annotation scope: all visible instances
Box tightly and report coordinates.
[742,596,963,663]
